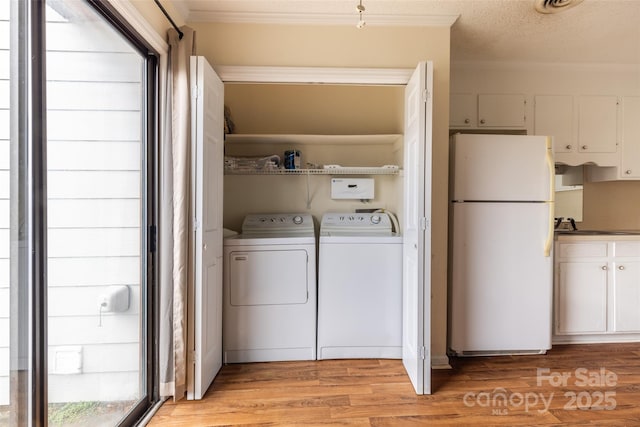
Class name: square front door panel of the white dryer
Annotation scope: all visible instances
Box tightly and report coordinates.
[229,249,309,306]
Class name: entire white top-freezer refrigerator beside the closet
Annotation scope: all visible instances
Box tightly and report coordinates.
[449,134,555,356]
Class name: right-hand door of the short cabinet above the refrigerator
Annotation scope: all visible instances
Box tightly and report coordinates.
[478,94,526,128]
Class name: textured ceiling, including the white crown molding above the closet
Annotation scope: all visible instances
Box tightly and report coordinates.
[173,0,640,64]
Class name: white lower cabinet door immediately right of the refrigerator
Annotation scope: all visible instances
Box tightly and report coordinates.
[555,261,608,335]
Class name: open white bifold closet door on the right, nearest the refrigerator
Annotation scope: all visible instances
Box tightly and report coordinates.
[402,62,433,394]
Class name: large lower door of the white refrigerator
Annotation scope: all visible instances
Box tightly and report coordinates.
[450,203,553,354]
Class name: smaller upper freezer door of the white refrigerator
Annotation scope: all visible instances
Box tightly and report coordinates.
[452,134,555,201]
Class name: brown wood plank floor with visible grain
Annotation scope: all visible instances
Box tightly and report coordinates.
[149,343,640,427]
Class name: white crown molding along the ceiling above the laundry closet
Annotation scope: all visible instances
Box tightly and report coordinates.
[187,10,459,27]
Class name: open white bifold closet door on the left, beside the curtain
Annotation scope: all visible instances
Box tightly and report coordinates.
[187,56,224,399]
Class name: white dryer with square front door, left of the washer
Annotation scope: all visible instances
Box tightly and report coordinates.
[222,213,317,363]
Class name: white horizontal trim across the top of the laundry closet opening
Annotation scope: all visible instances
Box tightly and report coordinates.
[214,65,414,85]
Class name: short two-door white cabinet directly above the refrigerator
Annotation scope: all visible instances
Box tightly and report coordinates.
[449,94,526,129]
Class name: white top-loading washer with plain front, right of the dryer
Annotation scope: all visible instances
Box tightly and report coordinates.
[317,213,402,359]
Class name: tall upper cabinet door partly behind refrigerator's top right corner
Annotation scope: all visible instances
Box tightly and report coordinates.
[533,95,575,153]
